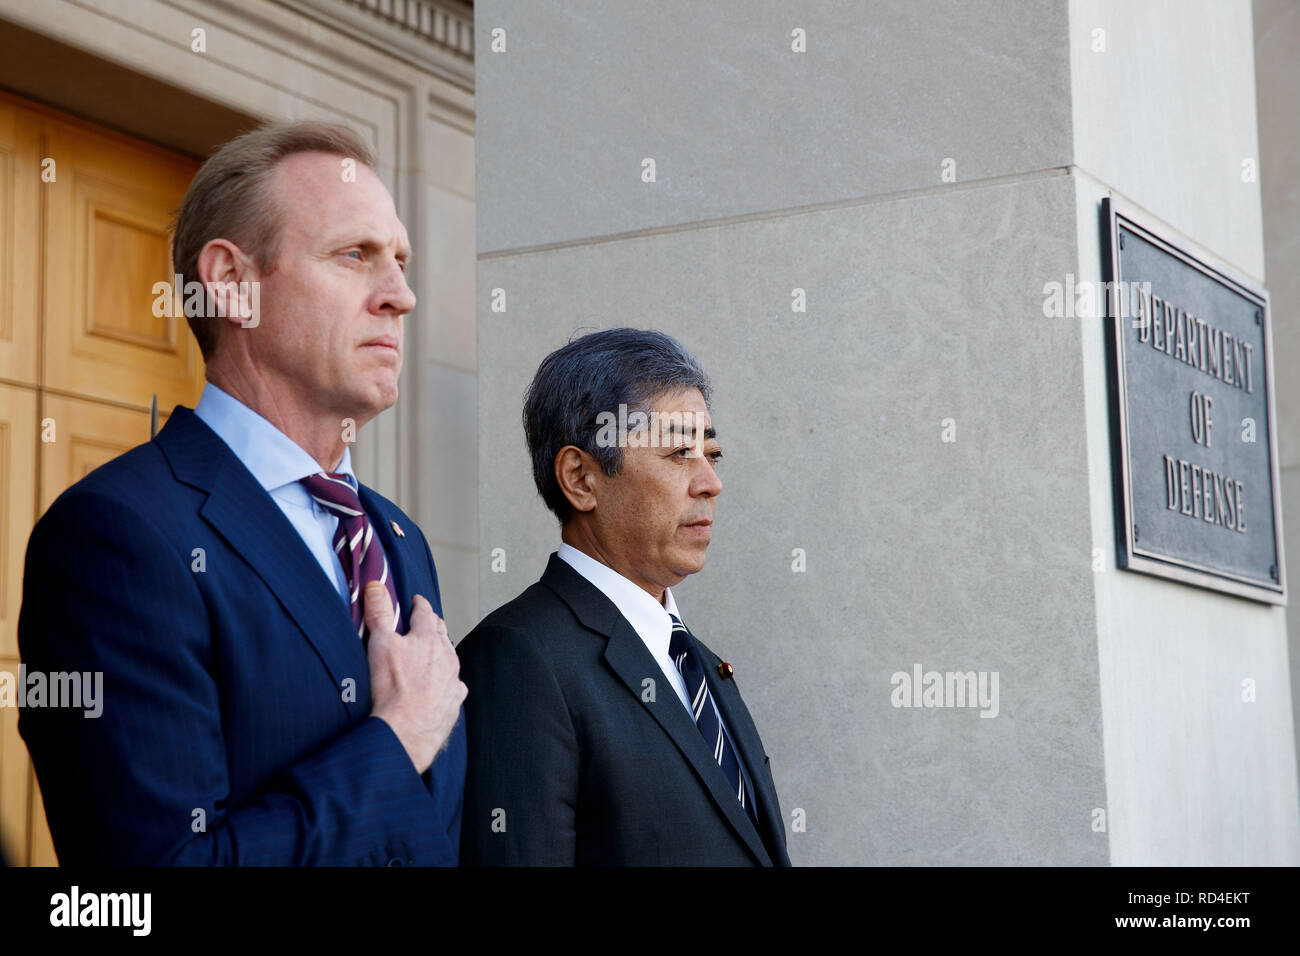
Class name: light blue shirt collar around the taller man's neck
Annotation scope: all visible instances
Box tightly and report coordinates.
[194,382,351,494]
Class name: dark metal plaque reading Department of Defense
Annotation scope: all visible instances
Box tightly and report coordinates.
[1104,199,1286,604]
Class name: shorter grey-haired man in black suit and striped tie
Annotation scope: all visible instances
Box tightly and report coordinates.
[458,329,790,866]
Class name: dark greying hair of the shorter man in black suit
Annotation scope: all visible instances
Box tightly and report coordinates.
[524,329,711,524]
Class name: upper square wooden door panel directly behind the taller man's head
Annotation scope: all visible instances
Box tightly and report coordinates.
[43,120,203,408]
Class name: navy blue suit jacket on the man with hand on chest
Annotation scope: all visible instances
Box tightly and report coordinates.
[18,406,465,865]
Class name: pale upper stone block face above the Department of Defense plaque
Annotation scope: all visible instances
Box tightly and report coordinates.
[1070,0,1268,278]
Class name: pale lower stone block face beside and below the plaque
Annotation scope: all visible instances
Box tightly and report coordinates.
[1078,171,1300,866]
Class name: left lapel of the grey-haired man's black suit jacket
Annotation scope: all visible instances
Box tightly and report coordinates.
[542,554,772,866]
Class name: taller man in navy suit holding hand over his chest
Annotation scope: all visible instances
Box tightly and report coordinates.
[18,124,465,865]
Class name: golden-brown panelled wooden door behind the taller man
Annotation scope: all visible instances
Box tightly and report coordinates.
[0,94,203,865]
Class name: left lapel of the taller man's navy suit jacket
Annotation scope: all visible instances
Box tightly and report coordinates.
[153,406,371,722]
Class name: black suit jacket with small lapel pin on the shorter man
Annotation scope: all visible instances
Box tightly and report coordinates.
[458,554,790,866]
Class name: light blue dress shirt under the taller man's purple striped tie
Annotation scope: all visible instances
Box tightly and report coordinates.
[194,382,358,607]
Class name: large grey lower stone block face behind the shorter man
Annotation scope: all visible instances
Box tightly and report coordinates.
[480,176,1108,864]
